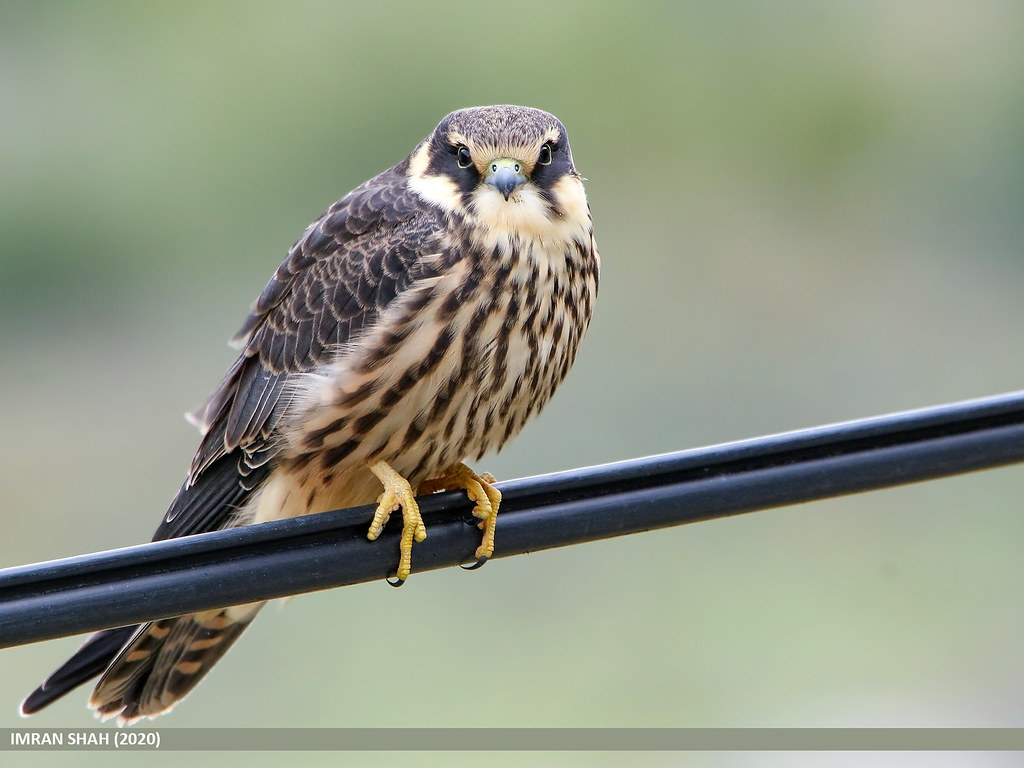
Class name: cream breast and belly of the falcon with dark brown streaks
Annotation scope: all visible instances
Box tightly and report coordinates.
[285,221,597,486]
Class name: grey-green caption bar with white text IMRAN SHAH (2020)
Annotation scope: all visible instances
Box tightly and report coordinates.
[6,728,1024,752]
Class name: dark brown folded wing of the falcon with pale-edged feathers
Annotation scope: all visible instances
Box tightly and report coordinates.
[156,158,444,539]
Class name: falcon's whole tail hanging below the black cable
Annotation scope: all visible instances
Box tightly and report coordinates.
[22,602,264,725]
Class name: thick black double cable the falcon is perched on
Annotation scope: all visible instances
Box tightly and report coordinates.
[6,392,1024,647]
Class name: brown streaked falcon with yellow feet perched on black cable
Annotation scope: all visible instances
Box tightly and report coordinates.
[22,105,600,724]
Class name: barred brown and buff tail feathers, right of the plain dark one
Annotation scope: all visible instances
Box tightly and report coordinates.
[89,603,264,725]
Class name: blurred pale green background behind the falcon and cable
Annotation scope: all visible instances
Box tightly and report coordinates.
[0,1,1024,765]
